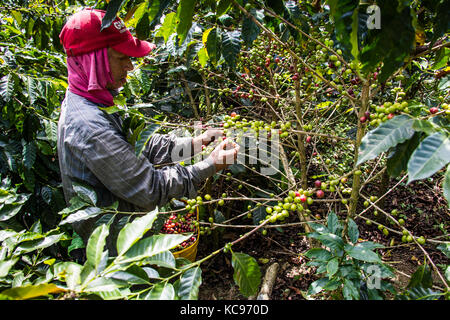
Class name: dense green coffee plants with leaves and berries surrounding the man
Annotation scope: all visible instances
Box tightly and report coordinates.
[0,0,450,300]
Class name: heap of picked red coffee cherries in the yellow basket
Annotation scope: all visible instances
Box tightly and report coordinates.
[161,210,199,251]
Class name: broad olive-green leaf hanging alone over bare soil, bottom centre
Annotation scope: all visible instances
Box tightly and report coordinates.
[231,252,261,297]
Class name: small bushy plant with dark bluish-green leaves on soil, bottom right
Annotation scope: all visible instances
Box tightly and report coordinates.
[305,212,395,300]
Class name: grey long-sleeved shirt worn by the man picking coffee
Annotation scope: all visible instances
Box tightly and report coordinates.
[57,91,215,249]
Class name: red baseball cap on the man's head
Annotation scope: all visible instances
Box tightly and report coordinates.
[59,9,156,57]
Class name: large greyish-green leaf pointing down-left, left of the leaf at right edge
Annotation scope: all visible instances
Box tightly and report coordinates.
[356,115,414,165]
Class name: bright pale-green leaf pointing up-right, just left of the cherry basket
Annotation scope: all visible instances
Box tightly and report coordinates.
[117,208,159,256]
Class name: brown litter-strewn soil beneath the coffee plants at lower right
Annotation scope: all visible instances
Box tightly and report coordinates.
[197,175,450,300]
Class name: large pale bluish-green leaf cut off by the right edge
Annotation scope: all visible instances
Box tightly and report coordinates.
[408,132,450,183]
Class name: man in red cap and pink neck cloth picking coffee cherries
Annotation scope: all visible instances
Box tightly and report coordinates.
[57,9,239,254]
